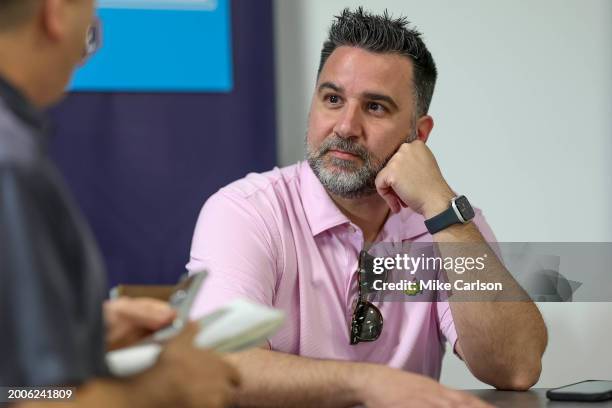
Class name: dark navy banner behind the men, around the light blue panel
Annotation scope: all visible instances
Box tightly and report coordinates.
[51,0,276,286]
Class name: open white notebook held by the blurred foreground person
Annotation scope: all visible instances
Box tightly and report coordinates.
[106,300,285,377]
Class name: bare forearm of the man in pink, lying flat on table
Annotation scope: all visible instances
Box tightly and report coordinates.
[227,349,367,407]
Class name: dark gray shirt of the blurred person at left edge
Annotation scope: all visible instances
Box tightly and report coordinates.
[0,77,107,386]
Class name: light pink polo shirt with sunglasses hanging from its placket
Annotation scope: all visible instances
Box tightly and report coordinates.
[187,162,495,379]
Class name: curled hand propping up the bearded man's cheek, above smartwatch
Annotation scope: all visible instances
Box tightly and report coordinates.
[376,140,455,218]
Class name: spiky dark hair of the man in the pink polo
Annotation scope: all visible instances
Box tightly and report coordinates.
[317,7,438,116]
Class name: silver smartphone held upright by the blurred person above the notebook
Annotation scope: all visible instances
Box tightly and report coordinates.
[153,271,208,343]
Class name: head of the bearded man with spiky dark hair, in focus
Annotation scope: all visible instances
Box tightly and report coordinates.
[306,8,437,198]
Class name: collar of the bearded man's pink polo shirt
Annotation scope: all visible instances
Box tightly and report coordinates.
[299,161,428,242]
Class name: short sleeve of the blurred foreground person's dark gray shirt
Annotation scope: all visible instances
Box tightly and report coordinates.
[0,167,106,386]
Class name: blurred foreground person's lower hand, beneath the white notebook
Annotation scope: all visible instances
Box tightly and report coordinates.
[154,323,240,408]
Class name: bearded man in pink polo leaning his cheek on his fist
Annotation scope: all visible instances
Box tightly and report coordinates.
[187,9,547,407]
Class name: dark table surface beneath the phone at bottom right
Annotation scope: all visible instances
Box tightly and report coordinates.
[466,388,612,408]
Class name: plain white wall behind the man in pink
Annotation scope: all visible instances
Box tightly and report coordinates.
[275,0,612,388]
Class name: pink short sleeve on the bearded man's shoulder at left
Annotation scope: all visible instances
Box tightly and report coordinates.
[187,190,278,319]
